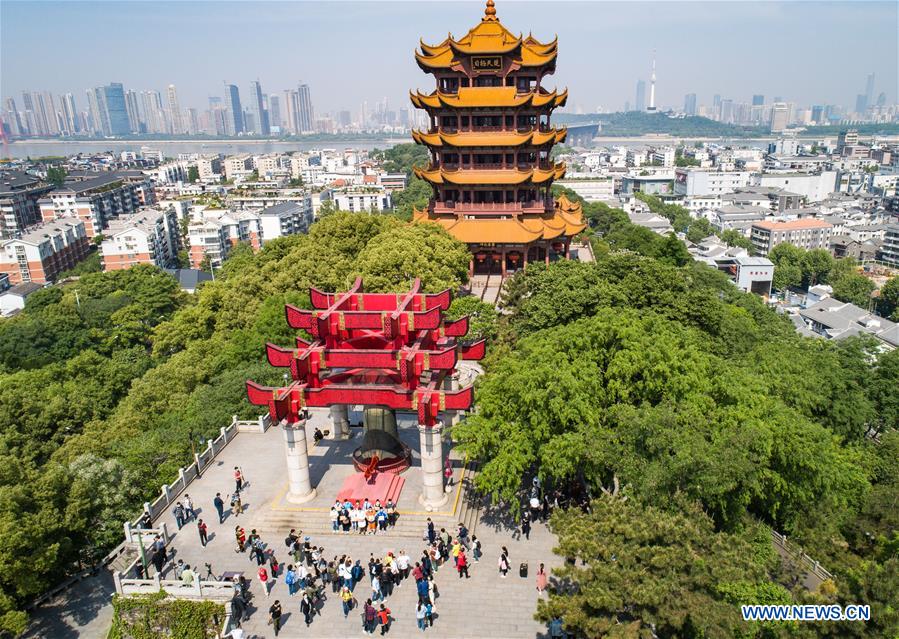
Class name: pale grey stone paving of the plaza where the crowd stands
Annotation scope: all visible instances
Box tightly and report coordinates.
[30,414,558,639]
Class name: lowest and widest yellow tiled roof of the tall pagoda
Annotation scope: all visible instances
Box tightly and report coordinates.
[412,196,587,244]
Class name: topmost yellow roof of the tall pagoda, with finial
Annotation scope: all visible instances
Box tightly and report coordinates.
[415,0,557,70]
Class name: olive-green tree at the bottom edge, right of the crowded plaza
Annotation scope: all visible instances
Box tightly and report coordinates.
[535,497,790,638]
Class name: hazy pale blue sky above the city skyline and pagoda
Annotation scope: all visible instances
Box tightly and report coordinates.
[0,0,899,113]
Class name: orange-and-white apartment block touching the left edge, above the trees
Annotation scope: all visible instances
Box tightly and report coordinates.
[0,219,90,284]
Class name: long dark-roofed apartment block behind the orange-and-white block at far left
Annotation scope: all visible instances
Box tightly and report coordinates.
[39,173,155,237]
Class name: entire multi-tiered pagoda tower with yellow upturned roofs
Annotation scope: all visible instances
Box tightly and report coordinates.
[410,0,586,275]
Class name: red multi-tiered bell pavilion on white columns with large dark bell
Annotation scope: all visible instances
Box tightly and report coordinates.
[247,279,485,507]
